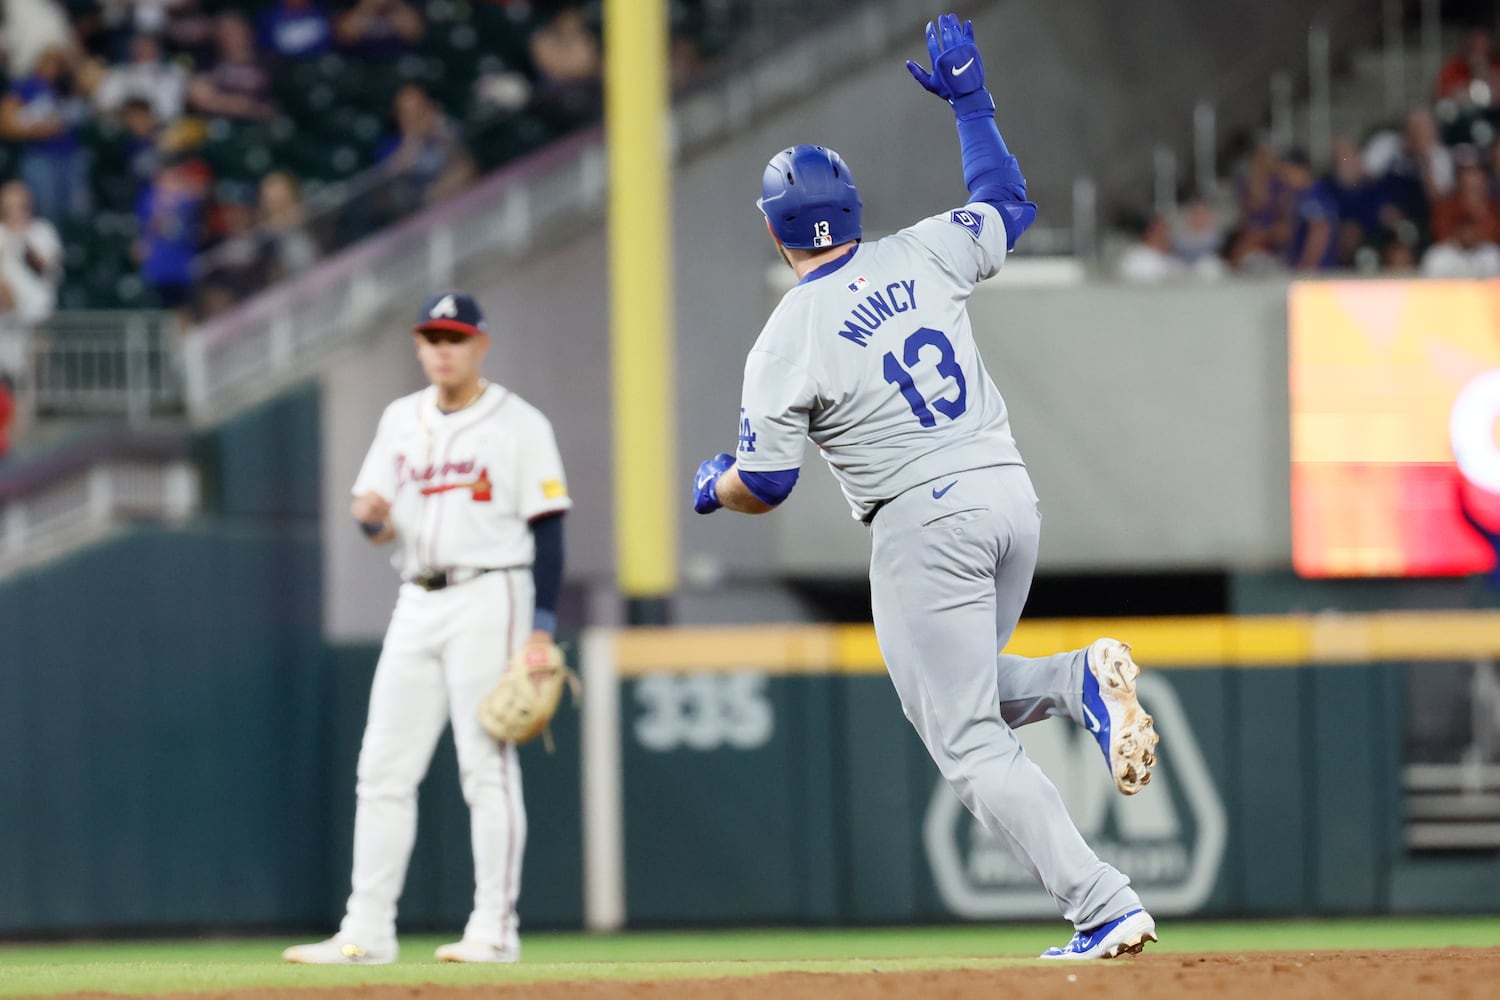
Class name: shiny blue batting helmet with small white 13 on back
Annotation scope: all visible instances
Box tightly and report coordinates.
[755,145,863,250]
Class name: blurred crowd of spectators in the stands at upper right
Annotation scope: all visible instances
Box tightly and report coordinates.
[1116,28,1500,282]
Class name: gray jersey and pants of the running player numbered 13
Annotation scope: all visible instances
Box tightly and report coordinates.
[737,204,1140,927]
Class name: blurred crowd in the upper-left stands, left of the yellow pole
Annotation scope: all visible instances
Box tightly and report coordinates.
[0,0,639,318]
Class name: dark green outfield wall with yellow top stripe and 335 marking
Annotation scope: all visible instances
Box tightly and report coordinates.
[0,385,1500,937]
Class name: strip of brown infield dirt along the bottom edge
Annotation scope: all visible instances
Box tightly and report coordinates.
[61,948,1500,1000]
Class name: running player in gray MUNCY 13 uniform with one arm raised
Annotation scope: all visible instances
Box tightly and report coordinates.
[693,15,1157,958]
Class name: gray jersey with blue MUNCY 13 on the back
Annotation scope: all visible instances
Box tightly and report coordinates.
[737,204,1023,520]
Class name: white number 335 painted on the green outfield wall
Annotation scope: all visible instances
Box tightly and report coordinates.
[633,672,776,753]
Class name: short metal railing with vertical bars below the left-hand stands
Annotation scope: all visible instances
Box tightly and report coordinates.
[29,310,185,421]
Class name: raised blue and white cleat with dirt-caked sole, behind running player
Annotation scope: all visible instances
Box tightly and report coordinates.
[1083,639,1160,795]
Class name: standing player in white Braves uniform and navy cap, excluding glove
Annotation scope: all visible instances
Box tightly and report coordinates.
[284,292,572,964]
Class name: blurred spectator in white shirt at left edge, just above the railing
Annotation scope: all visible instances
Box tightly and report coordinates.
[0,180,63,380]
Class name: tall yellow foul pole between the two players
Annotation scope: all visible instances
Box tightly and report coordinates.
[605,0,687,614]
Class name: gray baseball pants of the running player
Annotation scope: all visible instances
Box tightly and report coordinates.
[870,465,1140,930]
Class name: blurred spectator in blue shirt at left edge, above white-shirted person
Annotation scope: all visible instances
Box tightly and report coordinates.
[0,48,92,222]
